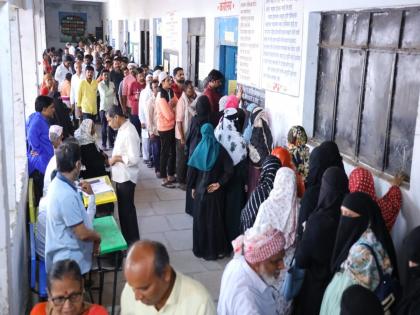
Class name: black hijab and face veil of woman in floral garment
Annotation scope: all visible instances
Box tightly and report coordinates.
[332,192,398,277]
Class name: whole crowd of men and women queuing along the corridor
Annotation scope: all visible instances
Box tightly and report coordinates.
[26,41,420,315]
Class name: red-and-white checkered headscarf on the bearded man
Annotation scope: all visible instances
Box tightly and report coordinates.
[232,227,286,264]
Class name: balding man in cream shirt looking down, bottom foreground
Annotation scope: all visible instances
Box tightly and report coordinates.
[121,240,216,315]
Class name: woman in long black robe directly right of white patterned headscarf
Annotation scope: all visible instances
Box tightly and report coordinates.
[294,166,349,315]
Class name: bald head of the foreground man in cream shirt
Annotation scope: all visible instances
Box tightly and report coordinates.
[124,240,172,305]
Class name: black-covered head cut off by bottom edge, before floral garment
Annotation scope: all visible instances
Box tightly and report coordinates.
[340,284,384,315]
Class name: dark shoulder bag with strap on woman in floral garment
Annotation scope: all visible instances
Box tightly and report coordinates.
[361,243,401,314]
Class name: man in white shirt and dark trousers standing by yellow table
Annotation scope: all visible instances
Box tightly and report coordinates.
[106,105,140,245]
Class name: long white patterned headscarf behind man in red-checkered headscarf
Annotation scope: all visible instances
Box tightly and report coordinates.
[254,167,298,249]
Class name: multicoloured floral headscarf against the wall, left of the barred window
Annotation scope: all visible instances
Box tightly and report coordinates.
[287,126,309,180]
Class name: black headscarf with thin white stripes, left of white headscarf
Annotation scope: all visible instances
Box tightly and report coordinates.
[241,155,281,232]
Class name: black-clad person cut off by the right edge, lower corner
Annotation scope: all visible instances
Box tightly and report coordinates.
[397,226,420,315]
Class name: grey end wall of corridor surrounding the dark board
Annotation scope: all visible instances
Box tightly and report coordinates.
[45,0,102,48]
